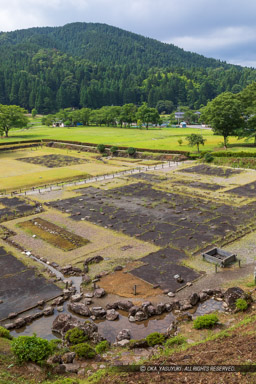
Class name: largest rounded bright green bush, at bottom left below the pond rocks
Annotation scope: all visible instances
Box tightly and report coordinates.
[12,334,52,363]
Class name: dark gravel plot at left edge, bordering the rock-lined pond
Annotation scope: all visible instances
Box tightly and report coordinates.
[0,248,62,320]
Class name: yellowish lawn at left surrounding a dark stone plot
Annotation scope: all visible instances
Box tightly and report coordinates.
[0,147,139,191]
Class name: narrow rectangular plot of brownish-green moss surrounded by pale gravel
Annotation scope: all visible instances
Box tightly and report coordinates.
[19,217,89,251]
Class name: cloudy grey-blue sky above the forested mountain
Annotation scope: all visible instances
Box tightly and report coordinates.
[0,0,256,67]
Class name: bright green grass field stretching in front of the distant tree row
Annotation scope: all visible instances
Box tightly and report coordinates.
[0,124,256,151]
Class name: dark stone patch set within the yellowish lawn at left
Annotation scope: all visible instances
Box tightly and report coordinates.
[17,155,86,168]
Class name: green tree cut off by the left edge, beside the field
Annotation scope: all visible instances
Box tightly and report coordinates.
[0,104,28,137]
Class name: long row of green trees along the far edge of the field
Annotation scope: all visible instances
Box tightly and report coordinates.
[42,103,161,128]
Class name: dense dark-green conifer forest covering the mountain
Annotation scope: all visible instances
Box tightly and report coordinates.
[0,23,256,114]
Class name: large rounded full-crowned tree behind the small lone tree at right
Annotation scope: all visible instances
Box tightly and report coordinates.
[201,92,245,148]
